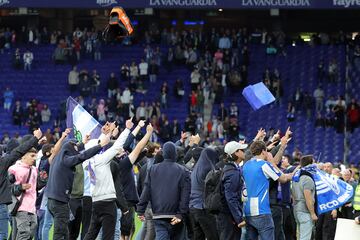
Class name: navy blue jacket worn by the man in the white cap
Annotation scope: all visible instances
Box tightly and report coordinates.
[222,163,244,225]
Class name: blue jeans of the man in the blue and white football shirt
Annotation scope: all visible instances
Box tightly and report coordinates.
[246,214,275,240]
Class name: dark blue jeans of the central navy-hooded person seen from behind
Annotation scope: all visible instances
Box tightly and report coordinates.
[153,219,185,240]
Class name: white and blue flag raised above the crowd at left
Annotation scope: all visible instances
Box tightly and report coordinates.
[66,97,101,142]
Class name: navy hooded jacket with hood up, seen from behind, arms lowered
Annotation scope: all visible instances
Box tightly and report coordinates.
[137,142,190,219]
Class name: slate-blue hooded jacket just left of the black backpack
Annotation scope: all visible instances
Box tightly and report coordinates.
[189,148,219,209]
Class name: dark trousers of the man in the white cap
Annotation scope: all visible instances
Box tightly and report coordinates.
[216,213,241,240]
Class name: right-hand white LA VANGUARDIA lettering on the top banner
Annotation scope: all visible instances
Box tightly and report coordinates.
[242,0,310,7]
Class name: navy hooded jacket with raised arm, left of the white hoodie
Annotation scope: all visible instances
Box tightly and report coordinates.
[46,140,101,203]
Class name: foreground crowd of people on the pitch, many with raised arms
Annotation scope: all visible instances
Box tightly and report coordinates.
[0,124,360,240]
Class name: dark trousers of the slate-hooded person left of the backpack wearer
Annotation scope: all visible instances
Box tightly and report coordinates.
[190,208,219,240]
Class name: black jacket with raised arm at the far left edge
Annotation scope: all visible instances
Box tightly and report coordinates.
[0,137,38,204]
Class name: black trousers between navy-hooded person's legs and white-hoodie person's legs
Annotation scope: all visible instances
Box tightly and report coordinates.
[69,198,82,240]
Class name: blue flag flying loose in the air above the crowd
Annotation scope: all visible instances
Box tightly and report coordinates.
[242,82,275,110]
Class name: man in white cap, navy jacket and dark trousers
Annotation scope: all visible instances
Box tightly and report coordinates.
[217,141,248,240]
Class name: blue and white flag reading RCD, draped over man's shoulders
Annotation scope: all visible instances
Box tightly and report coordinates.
[293,164,354,214]
